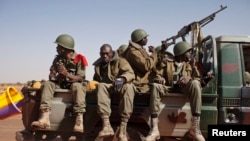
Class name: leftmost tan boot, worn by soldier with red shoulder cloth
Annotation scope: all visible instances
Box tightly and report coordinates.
[31,109,50,129]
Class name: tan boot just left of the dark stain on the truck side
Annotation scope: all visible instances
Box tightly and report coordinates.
[145,118,160,141]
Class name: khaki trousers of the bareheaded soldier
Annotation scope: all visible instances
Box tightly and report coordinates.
[97,83,135,122]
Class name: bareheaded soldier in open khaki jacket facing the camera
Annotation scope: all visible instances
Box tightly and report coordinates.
[93,44,135,141]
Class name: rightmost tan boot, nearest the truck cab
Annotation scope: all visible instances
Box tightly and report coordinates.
[189,116,205,141]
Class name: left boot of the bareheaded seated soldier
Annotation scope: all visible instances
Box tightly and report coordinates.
[98,116,114,138]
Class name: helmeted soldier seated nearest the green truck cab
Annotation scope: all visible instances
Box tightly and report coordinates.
[174,41,205,141]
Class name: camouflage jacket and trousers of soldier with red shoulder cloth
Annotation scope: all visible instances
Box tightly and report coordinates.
[40,53,86,113]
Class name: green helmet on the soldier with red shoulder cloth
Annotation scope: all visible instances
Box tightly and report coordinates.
[55,34,75,50]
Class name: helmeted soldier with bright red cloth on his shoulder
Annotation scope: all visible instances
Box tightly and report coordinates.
[31,34,87,133]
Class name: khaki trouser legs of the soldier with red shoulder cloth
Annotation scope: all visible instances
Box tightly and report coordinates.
[40,81,86,113]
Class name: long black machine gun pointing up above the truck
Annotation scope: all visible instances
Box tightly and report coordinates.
[163,5,227,46]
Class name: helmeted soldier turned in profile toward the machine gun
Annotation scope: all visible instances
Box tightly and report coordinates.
[125,29,168,141]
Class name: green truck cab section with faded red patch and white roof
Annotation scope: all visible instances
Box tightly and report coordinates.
[216,35,250,124]
